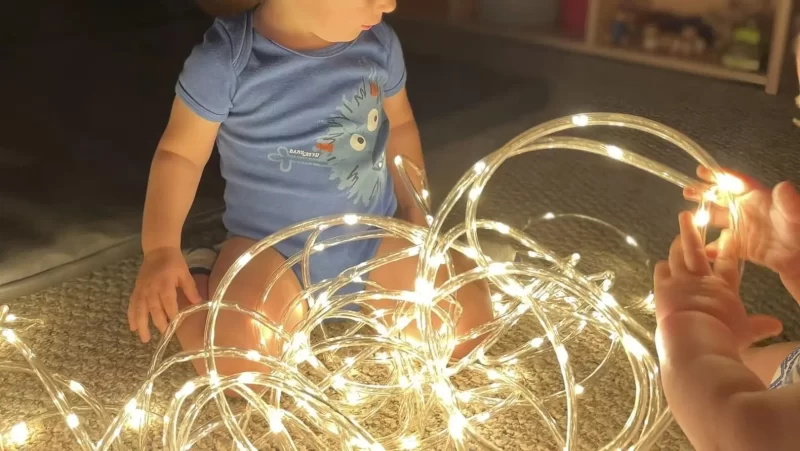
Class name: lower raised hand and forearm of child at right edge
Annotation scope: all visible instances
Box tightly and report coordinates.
[655,213,788,451]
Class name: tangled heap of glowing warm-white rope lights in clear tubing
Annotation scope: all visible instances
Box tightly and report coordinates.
[0,113,740,451]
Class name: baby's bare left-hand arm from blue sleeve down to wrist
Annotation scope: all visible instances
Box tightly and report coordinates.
[142,98,219,255]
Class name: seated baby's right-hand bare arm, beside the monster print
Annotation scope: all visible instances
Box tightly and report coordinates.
[383,88,427,226]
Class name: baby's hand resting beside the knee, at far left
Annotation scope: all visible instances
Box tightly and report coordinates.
[128,248,201,343]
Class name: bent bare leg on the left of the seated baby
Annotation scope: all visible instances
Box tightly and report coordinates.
[177,237,305,376]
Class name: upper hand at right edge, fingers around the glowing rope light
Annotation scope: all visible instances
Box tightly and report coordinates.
[684,167,800,278]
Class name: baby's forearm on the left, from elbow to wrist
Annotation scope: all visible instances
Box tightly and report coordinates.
[142,150,208,255]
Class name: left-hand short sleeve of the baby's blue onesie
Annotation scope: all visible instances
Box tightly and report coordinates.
[175,19,236,122]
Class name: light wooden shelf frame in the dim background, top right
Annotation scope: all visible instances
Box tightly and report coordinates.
[449,0,792,94]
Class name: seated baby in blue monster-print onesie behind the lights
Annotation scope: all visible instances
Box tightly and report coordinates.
[128,0,492,375]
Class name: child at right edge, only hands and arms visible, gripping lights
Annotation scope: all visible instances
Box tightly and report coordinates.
[654,169,800,451]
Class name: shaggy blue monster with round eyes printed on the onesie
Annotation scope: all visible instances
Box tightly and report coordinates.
[316,78,389,206]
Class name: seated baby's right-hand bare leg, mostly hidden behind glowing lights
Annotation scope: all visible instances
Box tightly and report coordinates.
[369,238,493,358]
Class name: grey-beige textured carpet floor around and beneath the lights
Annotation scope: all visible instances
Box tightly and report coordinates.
[0,15,800,450]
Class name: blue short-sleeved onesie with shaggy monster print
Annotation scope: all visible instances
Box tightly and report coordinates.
[176,11,406,291]
